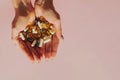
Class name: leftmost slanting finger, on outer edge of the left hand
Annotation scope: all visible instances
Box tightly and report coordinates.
[17,38,34,61]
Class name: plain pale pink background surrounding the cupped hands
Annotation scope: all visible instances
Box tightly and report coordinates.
[0,0,120,80]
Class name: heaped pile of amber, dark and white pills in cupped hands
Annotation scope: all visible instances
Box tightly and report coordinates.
[19,16,55,47]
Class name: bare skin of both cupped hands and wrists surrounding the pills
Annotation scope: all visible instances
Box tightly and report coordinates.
[12,0,62,61]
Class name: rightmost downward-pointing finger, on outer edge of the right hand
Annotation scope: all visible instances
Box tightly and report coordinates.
[51,34,59,57]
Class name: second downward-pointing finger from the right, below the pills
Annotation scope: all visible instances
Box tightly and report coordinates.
[44,41,52,58]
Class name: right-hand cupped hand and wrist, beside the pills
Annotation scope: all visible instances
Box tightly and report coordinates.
[35,0,62,58]
